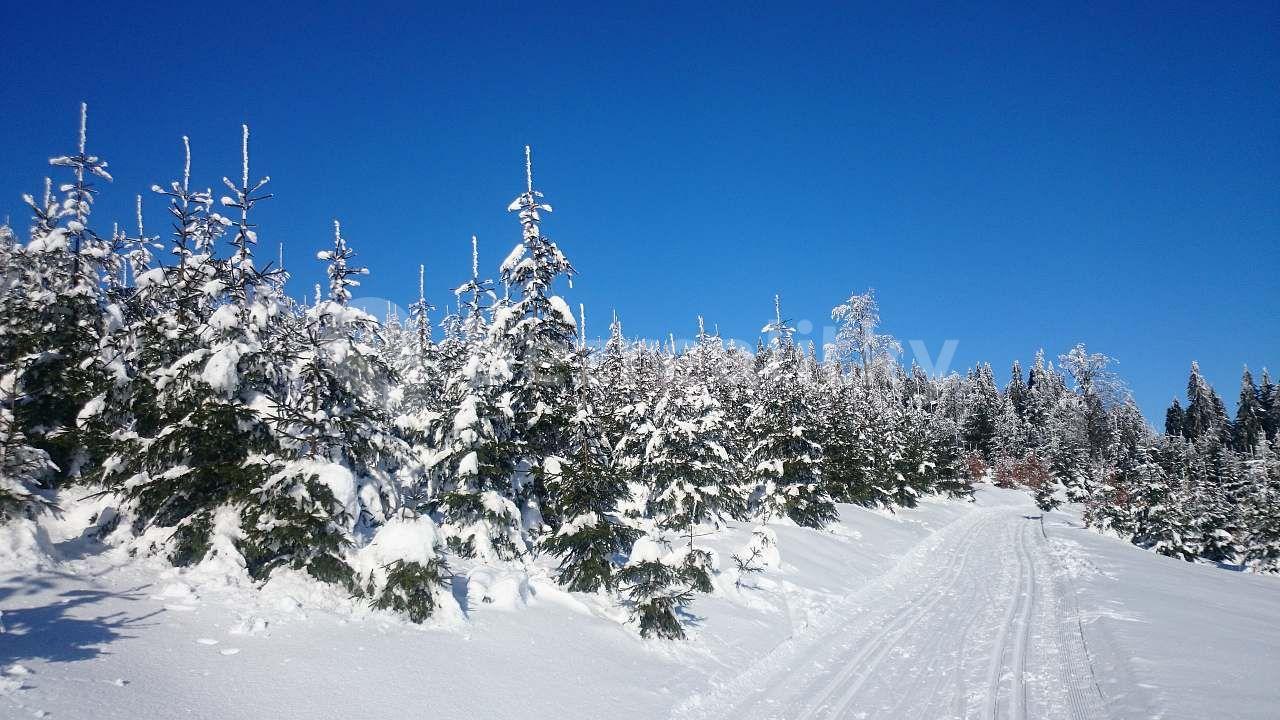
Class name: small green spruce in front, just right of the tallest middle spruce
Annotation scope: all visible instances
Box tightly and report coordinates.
[540,345,640,592]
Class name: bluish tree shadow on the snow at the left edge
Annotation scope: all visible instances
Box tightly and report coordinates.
[0,578,161,667]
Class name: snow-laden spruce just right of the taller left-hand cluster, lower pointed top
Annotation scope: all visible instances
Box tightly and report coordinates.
[241,220,407,589]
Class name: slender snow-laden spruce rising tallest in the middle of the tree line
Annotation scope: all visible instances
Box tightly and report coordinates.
[492,146,577,533]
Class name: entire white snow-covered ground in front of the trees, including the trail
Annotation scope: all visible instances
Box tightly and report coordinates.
[0,487,1280,720]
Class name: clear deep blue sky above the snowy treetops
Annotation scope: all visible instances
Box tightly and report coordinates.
[0,3,1280,419]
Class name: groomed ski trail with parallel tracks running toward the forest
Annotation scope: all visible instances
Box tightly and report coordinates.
[672,505,1108,720]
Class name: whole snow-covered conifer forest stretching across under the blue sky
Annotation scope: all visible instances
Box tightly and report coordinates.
[0,103,1280,717]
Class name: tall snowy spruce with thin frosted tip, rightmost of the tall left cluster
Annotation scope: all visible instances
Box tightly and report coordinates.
[108,126,288,565]
